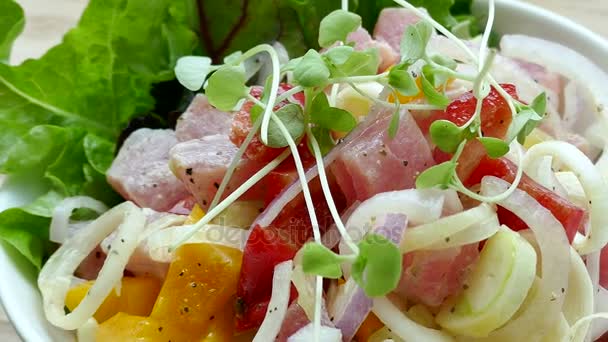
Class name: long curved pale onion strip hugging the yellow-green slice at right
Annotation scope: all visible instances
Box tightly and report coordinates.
[481,176,570,341]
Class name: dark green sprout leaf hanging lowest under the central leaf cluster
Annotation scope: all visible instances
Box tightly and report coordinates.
[310,92,357,132]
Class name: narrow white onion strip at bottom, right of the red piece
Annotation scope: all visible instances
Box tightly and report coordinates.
[253,260,293,342]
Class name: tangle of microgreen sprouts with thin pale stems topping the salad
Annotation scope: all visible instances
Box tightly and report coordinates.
[170,0,546,340]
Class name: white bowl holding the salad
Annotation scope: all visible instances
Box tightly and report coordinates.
[0,0,608,341]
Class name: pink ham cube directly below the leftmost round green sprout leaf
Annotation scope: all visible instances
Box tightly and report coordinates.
[175,94,232,141]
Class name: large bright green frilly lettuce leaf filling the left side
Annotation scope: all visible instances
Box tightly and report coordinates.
[0,0,198,268]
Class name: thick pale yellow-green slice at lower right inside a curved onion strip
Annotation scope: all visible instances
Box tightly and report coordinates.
[437,228,536,337]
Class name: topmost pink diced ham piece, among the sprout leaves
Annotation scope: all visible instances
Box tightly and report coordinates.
[374,7,420,52]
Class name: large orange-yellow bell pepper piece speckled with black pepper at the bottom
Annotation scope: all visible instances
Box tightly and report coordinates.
[97,243,242,342]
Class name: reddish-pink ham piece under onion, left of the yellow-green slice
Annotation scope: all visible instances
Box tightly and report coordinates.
[395,243,479,306]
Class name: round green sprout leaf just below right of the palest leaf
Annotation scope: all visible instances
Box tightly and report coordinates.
[205,66,249,111]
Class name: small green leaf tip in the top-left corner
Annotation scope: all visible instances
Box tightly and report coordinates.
[0,0,25,63]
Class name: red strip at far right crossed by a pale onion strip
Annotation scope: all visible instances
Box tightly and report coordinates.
[465,156,587,243]
